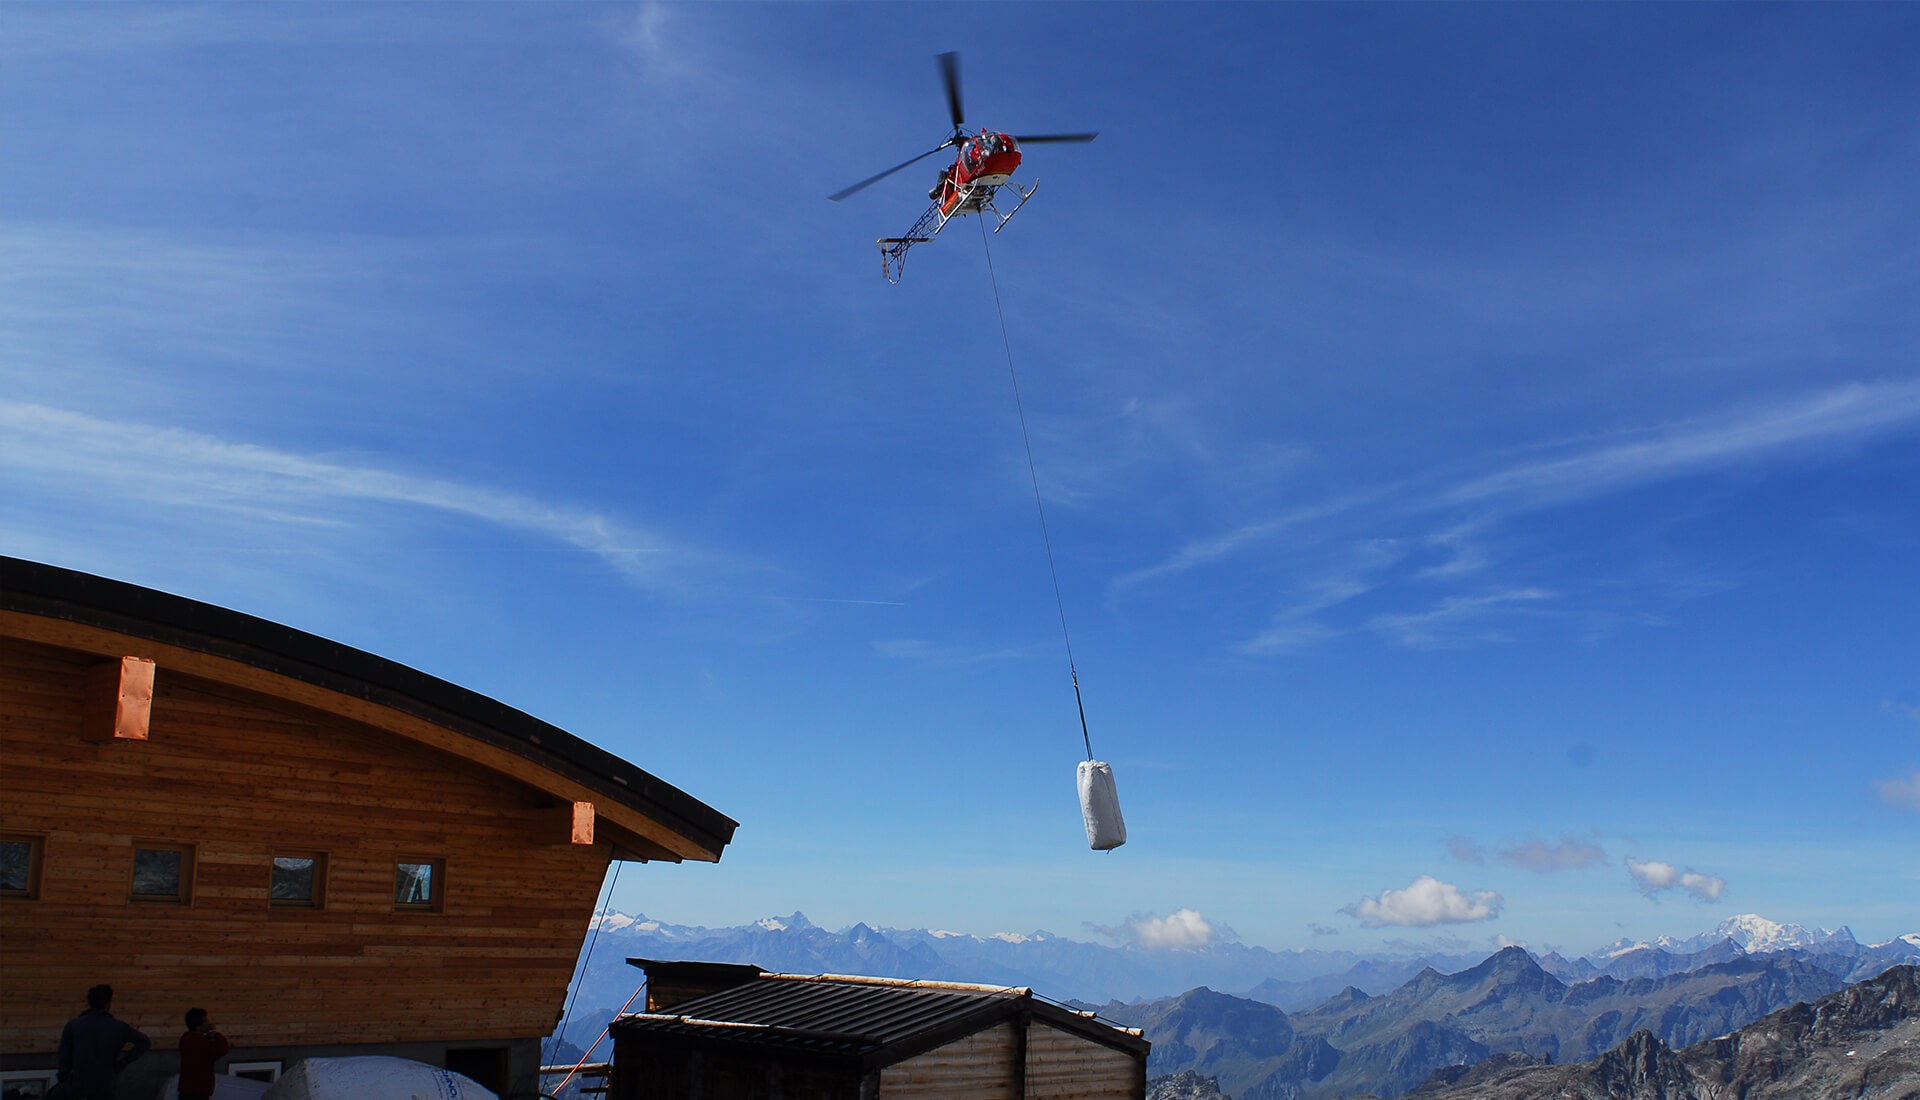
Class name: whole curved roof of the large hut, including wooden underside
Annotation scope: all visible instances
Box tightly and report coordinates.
[0,557,737,862]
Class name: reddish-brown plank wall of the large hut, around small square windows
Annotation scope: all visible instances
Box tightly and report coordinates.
[0,637,611,1054]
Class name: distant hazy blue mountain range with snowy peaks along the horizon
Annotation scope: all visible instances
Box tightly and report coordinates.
[564,912,1920,1100]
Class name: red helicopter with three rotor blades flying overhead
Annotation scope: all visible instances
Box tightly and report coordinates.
[828,52,1100,282]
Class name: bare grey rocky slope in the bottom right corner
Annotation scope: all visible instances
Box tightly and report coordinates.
[1407,966,1920,1100]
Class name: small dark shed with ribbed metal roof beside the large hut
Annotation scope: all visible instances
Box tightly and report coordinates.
[609,960,1148,1100]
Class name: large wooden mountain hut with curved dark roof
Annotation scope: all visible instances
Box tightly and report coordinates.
[0,559,735,1096]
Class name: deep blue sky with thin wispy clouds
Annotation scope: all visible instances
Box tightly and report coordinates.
[0,4,1920,950]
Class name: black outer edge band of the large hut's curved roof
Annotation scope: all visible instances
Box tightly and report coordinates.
[0,557,737,856]
